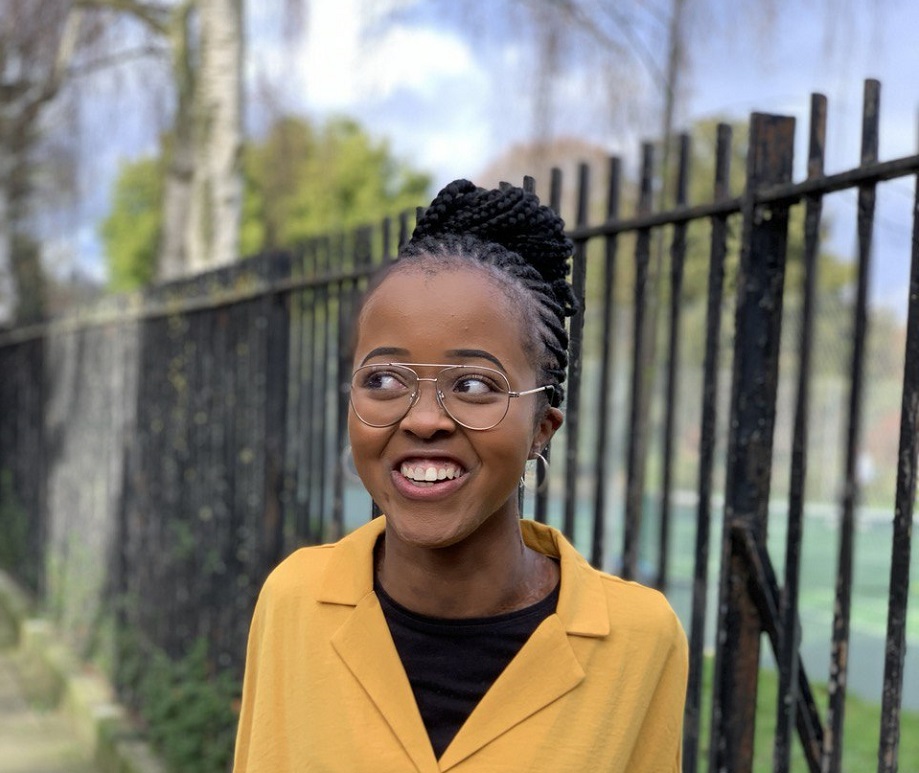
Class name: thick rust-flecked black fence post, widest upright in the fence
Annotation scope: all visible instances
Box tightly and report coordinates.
[710,114,795,773]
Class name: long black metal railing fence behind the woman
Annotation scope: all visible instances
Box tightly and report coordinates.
[0,82,919,771]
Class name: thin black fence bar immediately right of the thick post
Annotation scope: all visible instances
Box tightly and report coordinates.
[772,94,826,773]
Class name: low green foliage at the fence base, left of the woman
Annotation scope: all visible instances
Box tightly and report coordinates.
[119,638,240,773]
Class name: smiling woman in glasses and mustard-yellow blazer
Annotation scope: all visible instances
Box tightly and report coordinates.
[235,180,686,773]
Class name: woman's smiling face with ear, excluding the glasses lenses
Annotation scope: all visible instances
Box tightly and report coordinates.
[348,268,562,548]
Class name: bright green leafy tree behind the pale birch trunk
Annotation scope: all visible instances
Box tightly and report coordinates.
[100,111,430,291]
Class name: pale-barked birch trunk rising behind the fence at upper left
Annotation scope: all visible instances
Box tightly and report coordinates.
[82,0,243,279]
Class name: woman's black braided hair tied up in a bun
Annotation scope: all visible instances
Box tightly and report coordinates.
[392,180,577,406]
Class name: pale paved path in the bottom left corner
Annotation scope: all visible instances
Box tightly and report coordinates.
[0,650,97,773]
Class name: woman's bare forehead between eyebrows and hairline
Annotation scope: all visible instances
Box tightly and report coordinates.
[354,267,531,370]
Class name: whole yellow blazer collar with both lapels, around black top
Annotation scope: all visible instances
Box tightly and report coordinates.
[319,517,610,772]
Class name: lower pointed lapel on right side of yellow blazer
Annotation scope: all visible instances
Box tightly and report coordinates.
[440,615,584,771]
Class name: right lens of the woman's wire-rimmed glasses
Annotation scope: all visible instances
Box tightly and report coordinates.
[437,365,510,429]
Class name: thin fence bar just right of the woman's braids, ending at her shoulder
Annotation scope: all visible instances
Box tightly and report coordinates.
[564,164,590,540]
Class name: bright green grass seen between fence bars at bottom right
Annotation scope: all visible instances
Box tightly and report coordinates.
[699,658,919,773]
